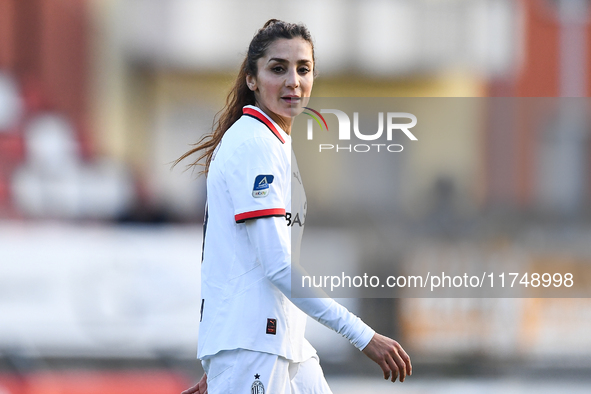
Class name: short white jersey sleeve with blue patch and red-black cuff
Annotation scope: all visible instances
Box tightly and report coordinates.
[226,138,290,223]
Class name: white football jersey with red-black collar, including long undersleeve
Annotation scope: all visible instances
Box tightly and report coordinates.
[198,106,374,362]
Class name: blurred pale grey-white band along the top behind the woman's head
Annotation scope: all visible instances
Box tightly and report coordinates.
[120,0,520,76]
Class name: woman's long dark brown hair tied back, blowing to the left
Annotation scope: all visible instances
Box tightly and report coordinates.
[172,19,316,175]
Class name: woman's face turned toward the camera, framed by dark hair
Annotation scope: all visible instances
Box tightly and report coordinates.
[246,37,314,133]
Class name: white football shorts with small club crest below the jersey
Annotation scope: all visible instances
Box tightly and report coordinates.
[201,349,332,394]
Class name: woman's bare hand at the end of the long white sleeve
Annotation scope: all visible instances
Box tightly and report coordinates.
[363,333,412,382]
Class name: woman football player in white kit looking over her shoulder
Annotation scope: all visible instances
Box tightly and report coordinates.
[177,19,412,394]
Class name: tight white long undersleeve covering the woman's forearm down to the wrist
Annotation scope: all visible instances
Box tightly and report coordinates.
[246,218,375,350]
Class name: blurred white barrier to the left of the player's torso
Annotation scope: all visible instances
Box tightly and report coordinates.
[0,221,202,358]
